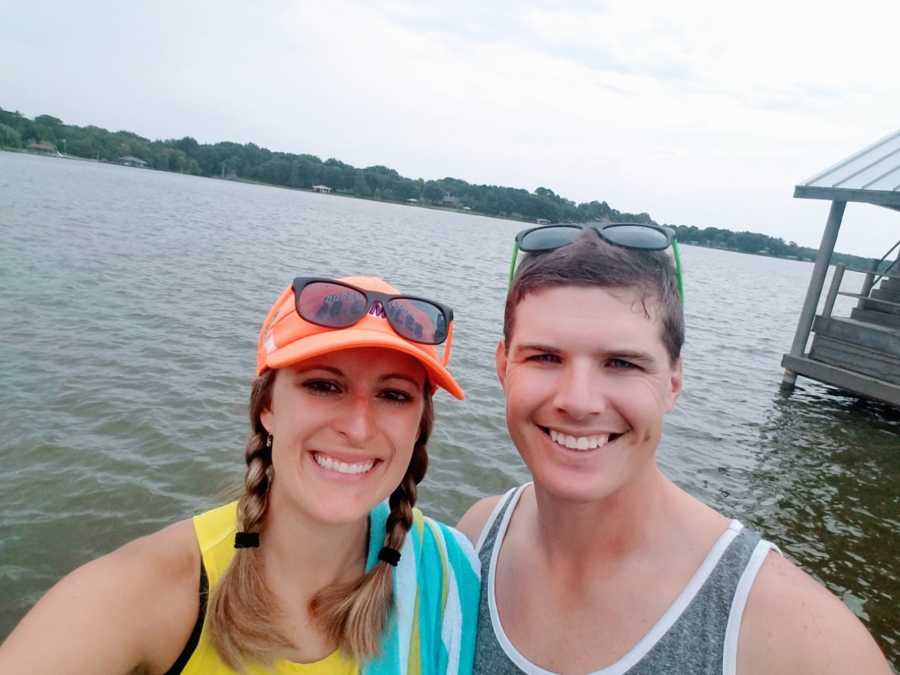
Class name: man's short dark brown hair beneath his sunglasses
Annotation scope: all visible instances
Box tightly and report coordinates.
[503,228,684,364]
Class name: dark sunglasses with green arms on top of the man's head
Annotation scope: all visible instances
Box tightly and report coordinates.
[509,223,684,304]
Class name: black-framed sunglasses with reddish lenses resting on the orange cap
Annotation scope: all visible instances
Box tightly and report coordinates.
[293,277,453,345]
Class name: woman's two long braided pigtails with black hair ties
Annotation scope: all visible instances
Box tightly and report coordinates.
[206,370,434,671]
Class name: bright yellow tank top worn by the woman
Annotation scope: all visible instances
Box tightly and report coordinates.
[181,502,359,675]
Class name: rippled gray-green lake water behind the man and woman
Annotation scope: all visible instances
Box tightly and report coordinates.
[0,152,900,667]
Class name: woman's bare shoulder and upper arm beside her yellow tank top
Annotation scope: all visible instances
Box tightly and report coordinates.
[0,520,200,672]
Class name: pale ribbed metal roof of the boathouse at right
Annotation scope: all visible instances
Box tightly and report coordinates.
[794,131,900,211]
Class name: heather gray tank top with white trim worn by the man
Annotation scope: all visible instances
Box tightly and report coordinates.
[473,485,774,675]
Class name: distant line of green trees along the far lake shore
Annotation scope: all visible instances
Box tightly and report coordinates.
[0,108,874,270]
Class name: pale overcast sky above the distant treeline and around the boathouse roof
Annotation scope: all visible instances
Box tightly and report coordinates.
[0,0,900,256]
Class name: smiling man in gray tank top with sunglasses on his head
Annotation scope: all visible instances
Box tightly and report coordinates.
[459,225,890,675]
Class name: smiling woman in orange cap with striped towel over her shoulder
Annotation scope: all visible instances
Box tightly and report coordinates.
[0,277,479,675]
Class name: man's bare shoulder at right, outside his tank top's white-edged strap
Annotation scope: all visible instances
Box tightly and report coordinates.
[738,552,890,674]
